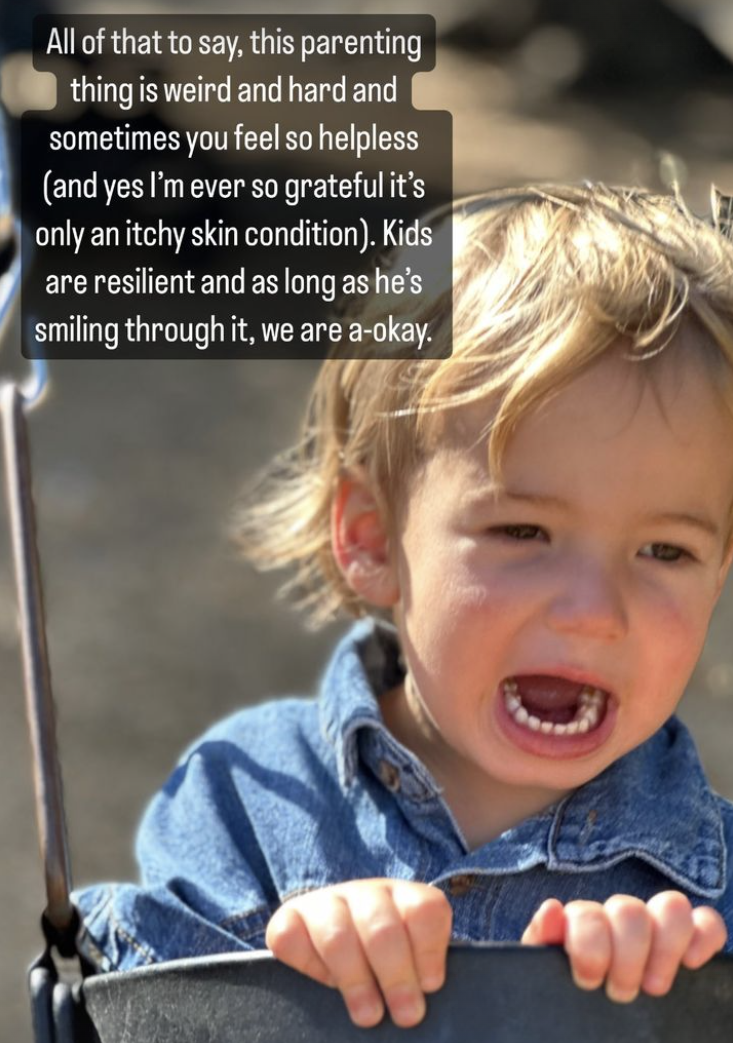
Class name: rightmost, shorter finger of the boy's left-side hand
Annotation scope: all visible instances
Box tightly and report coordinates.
[392,883,453,992]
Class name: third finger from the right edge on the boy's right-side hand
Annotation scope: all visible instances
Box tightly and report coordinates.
[604,895,654,1003]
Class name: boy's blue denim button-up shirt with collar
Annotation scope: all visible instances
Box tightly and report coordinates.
[74,621,733,970]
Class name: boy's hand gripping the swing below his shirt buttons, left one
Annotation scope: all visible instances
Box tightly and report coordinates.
[266,879,451,1028]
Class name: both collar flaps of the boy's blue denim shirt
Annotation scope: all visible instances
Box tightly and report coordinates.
[320,620,727,898]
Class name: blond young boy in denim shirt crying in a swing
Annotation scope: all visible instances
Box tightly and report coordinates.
[77,186,733,1026]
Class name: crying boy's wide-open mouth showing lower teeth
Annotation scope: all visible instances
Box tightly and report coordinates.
[502,674,610,736]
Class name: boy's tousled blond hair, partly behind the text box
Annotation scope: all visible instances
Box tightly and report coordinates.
[240,185,733,624]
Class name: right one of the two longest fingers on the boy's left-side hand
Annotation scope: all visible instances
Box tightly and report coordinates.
[349,886,425,1028]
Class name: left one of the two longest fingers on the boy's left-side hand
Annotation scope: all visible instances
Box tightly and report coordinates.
[300,891,385,1028]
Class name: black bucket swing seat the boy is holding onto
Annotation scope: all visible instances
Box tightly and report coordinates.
[30,945,733,1043]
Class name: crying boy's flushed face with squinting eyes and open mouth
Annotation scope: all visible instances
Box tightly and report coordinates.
[389,344,733,806]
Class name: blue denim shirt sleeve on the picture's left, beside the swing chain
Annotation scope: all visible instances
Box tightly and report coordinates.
[73,737,279,971]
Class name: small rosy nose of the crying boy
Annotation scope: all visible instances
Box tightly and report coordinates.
[547,560,629,640]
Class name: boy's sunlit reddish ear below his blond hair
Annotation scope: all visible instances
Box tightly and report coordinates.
[331,472,399,608]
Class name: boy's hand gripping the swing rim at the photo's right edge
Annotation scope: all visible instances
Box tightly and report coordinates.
[521,891,727,1003]
